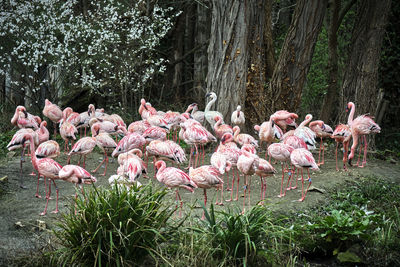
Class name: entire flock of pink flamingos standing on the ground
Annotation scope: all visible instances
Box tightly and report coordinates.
[7,95,381,218]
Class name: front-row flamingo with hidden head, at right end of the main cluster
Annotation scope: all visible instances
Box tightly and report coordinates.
[290,148,319,201]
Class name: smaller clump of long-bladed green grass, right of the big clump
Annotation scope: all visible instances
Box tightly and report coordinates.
[197,205,290,265]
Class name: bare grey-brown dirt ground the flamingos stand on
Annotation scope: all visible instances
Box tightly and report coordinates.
[0,144,400,266]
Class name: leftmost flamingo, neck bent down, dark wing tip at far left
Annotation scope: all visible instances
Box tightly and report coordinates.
[7,128,39,189]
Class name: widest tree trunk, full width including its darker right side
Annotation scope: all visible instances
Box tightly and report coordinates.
[207,0,270,130]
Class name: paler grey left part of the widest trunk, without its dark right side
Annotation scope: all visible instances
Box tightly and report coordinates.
[207,0,248,124]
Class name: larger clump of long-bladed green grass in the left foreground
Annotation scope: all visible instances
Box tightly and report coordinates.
[54,186,173,266]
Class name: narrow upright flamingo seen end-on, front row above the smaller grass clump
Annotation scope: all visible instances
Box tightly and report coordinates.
[237,144,260,213]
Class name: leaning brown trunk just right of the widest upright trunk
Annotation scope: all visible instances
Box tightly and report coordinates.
[266,0,327,114]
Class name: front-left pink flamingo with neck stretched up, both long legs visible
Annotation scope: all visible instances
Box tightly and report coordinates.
[24,134,62,215]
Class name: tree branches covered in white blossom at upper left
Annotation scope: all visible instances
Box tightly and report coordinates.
[0,0,177,113]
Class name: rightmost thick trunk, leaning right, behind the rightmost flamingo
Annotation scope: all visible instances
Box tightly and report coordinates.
[340,0,391,121]
